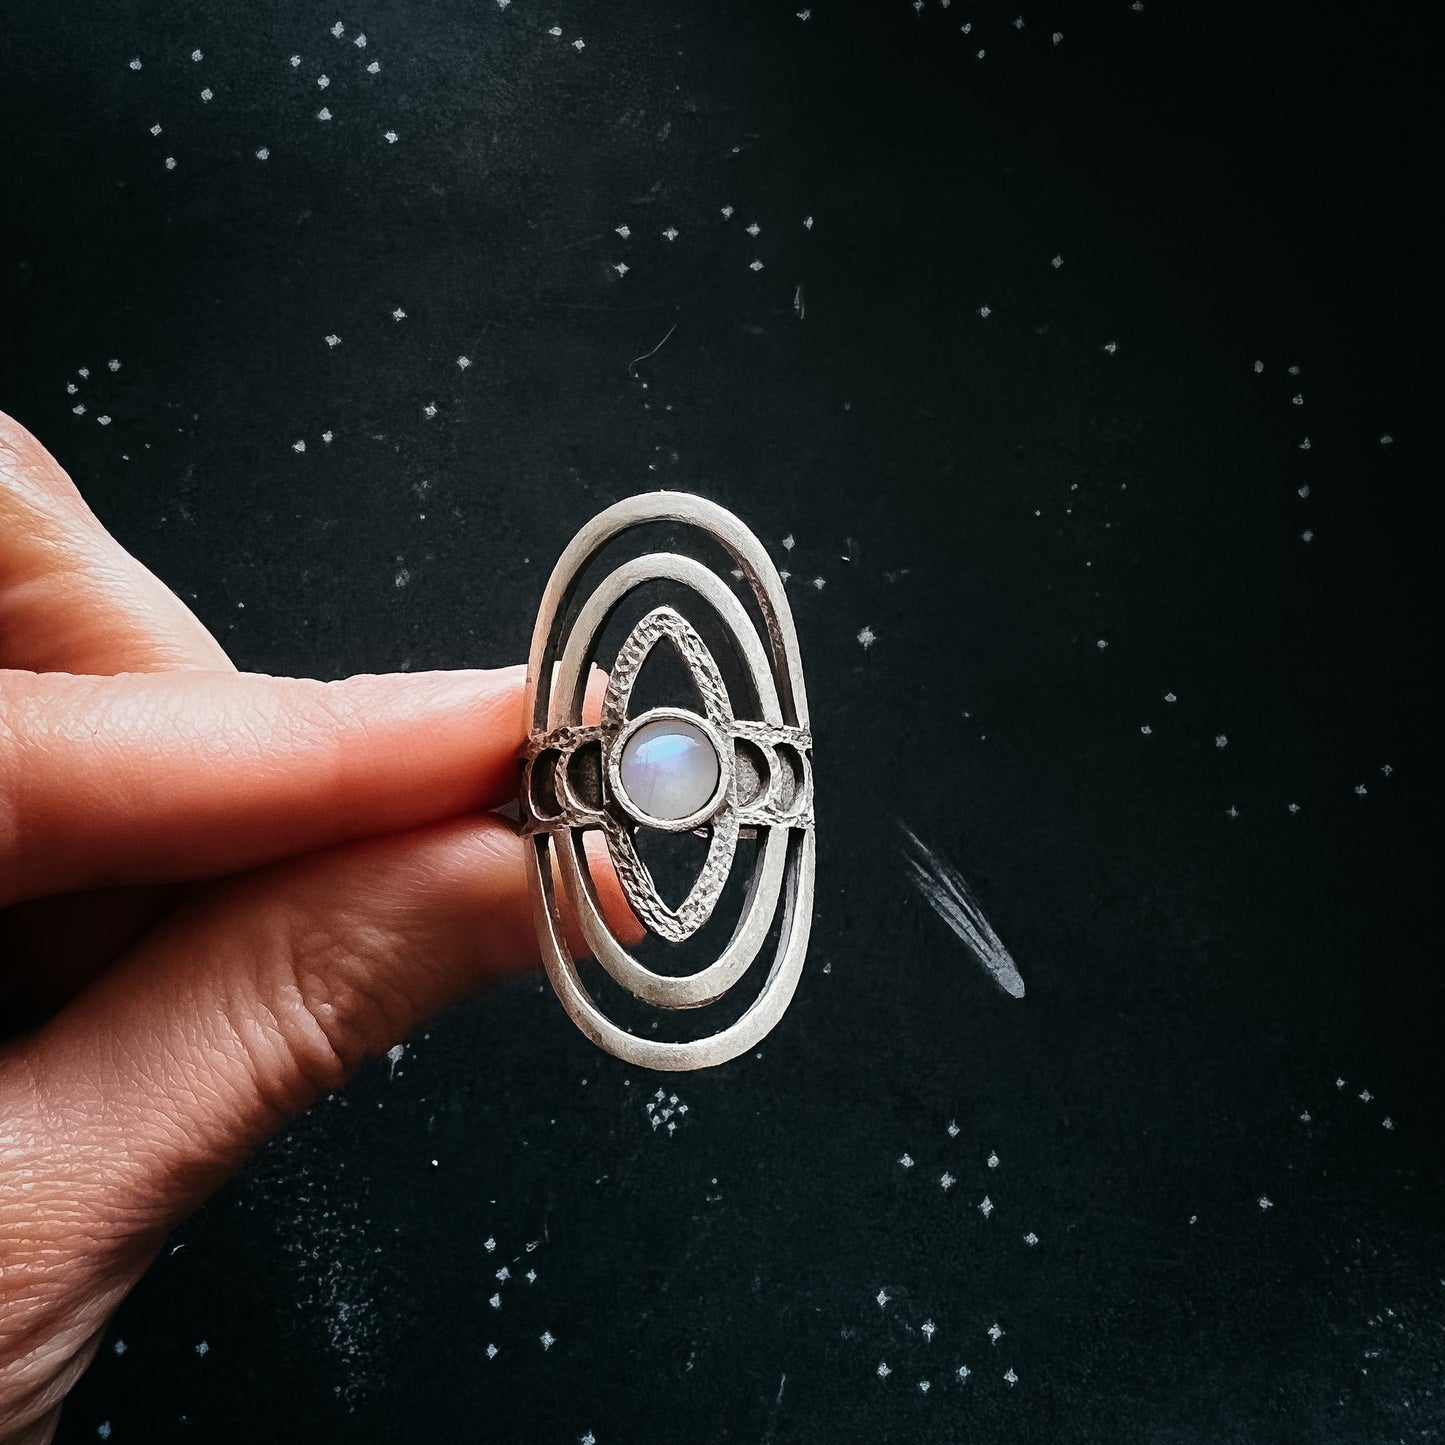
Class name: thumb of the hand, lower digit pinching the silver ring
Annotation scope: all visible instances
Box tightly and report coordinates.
[11,815,627,1235]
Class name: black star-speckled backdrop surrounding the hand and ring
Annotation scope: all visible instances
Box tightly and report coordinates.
[0,0,1445,1445]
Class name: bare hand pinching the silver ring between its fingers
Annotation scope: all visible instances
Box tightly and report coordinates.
[0,413,640,1445]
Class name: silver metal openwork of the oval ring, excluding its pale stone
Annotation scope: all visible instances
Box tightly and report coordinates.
[522,491,815,1071]
